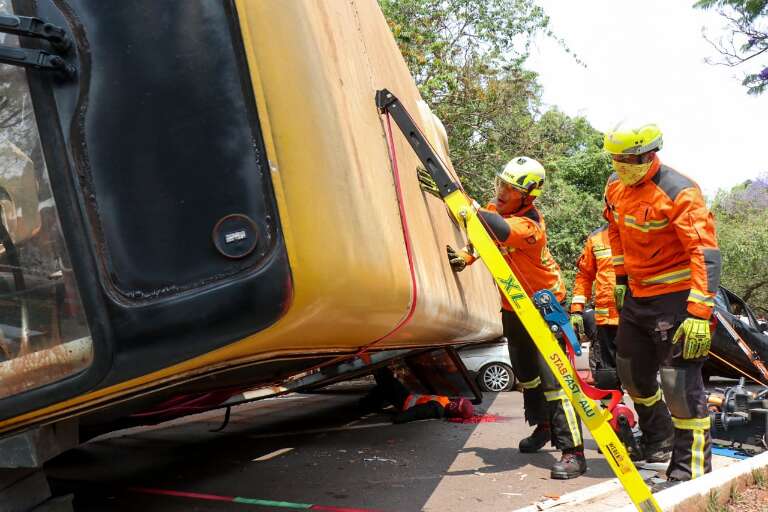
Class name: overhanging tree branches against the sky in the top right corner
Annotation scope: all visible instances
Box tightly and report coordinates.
[694,0,768,95]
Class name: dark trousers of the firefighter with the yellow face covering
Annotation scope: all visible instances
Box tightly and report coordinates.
[616,291,712,480]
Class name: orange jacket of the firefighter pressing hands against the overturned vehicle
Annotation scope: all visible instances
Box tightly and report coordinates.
[468,203,565,311]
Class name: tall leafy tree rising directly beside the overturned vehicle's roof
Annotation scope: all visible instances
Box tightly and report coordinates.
[379,0,584,200]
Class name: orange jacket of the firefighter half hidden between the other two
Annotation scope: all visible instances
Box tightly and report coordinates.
[571,225,619,325]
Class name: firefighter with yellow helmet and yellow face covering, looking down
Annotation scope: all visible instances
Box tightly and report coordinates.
[604,124,720,482]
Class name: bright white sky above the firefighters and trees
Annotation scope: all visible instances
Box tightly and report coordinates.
[526,0,768,197]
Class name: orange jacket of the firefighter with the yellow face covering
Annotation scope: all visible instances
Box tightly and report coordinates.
[603,157,720,319]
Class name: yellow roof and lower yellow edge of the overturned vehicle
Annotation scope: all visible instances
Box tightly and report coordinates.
[0,0,501,432]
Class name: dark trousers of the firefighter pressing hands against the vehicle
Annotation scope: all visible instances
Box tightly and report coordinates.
[501,310,584,450]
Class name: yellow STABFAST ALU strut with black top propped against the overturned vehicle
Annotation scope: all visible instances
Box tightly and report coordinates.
[376,89,661,512]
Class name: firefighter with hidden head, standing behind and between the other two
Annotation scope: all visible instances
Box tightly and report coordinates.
[571,224,621,389]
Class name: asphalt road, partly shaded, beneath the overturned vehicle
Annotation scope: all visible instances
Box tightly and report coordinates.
[47,384,612,512]
